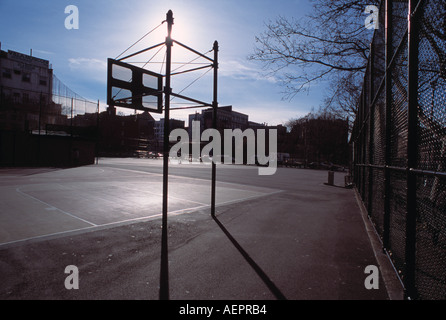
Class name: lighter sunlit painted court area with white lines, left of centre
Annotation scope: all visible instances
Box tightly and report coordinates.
[0,160,281,245]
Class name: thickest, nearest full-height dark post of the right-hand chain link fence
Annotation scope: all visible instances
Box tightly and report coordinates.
[404,0,420,299]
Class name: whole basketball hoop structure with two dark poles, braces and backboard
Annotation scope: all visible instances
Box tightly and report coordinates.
[107,10,219,300]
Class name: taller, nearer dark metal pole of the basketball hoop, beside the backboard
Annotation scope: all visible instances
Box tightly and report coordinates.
[159,10,173,300]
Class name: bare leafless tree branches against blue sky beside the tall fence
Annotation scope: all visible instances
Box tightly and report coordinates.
[249,0,380,118]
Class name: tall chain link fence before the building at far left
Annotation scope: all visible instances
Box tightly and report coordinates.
[0,76,99,167]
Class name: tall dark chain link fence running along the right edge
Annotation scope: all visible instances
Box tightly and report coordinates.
[351,0,446,300]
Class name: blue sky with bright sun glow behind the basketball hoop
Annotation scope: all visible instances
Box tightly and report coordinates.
[0,0,324,125]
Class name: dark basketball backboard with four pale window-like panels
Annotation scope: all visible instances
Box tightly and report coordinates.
[107,59,163,113]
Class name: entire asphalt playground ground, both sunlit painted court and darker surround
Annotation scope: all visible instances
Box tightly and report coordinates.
[0,159,399,300]
